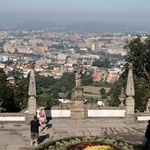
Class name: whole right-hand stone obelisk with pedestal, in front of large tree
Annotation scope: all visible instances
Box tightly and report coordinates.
[125,63,136,123]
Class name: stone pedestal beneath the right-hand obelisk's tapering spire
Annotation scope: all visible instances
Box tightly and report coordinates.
[125,97,136,124]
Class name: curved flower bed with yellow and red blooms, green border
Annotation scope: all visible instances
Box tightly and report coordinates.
[32,136,142,150]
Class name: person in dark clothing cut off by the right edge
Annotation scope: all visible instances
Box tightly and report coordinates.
[145,120,150,150]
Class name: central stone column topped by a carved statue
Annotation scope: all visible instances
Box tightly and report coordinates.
[71,64,86,119]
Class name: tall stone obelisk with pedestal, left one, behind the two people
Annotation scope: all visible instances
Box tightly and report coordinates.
[26,64,37,122]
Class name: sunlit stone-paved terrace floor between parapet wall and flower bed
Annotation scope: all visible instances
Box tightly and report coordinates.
[0,118,147,150]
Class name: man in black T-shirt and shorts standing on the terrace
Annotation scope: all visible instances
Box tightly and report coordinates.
[30,116,40,146]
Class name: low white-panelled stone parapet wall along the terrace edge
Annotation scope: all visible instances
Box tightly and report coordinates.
[0,106,150,122]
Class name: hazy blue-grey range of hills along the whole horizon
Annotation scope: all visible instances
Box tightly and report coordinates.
[0,16,150,33]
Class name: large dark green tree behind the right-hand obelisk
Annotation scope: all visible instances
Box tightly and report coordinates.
[121,35,150,111]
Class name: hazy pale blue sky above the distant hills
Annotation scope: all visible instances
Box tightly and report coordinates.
[0,0,150,25]
